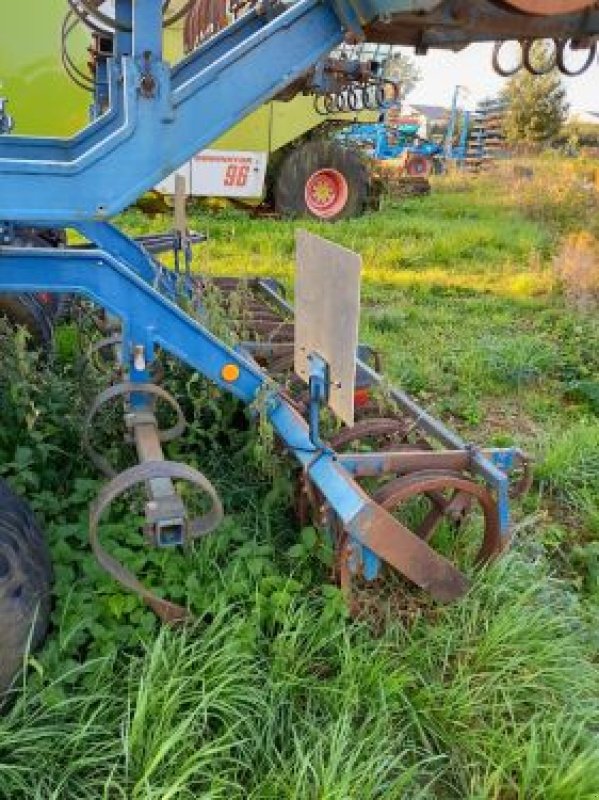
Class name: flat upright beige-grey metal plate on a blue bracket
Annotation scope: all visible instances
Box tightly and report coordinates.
[294,230,362,425]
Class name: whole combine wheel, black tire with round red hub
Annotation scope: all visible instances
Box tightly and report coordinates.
[275,140,369,222]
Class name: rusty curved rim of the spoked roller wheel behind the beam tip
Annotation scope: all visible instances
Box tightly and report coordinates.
[374,470,504,564]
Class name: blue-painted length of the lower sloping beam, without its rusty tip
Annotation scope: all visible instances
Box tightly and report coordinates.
[0,248,380,536]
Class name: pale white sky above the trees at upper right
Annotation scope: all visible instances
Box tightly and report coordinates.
[406,44,599,111]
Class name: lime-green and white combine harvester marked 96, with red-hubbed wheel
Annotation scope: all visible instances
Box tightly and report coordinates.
[0,0,390,220]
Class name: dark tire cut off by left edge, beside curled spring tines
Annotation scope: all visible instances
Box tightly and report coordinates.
[0,480,52,696]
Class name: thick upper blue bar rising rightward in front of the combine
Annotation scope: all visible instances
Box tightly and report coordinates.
[0,0,343,224]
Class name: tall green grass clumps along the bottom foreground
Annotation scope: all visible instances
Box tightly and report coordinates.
[0,555,599,800]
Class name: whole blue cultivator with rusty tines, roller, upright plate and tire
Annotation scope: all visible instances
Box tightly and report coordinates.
[0,0,599,686]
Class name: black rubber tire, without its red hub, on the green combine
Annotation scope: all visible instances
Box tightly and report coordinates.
[275,139,370,222]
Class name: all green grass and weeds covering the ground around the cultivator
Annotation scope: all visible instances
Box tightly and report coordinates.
[0,155,599,800]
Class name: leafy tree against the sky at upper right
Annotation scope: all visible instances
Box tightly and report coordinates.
[503,43,569,144]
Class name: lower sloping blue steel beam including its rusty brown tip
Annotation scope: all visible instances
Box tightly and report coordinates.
[0,247,467,601]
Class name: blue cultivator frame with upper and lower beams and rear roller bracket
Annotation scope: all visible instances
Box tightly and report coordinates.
[0,0,599,612]
